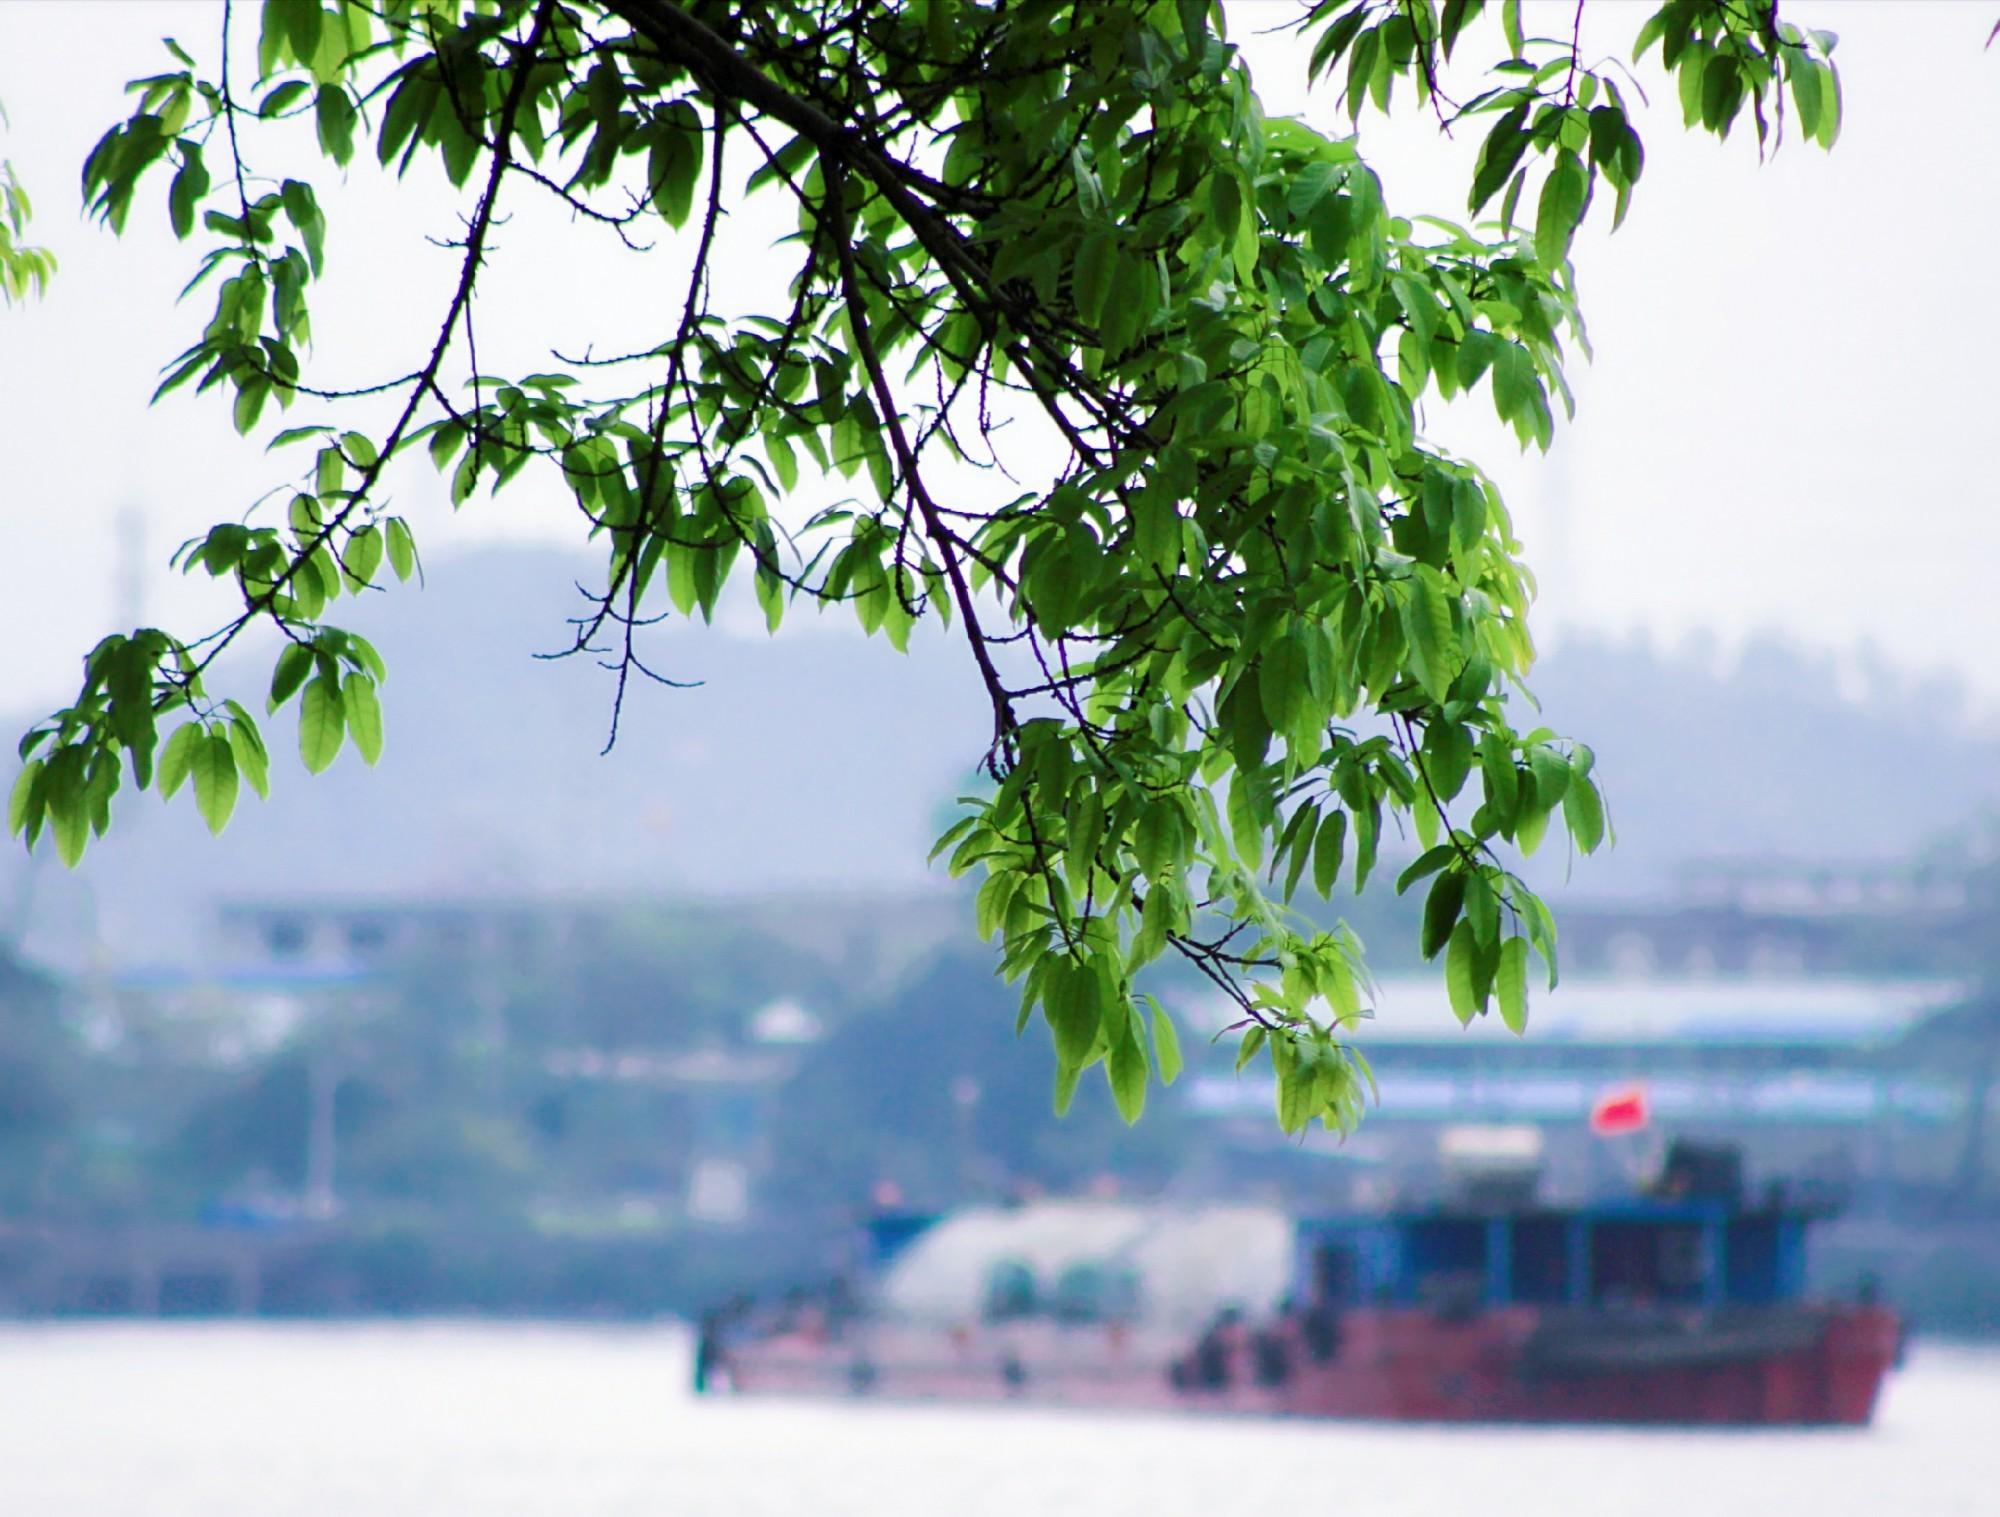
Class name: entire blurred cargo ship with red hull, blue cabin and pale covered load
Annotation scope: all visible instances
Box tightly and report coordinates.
[700,1145,1902,1427]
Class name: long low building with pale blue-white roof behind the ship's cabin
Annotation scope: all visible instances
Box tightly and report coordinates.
[1182,977,2000,1193]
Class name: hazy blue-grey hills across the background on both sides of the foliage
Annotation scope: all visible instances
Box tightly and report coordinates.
[0,548,2000,963]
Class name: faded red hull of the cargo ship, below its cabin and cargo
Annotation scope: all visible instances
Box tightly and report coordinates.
[720,1307,1900,1427]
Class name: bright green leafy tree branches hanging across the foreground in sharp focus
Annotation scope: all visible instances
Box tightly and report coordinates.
[10,0,1838,1131]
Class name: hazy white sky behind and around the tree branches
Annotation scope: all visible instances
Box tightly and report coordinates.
[0,0,2000,710]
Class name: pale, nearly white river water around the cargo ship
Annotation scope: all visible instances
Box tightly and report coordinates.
[0,1323,2000,1517]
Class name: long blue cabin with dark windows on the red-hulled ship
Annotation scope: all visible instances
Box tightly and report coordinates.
[1294,1197,1812,1311]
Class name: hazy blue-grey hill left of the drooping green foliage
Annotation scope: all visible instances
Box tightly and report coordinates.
[6,548,990,959]
